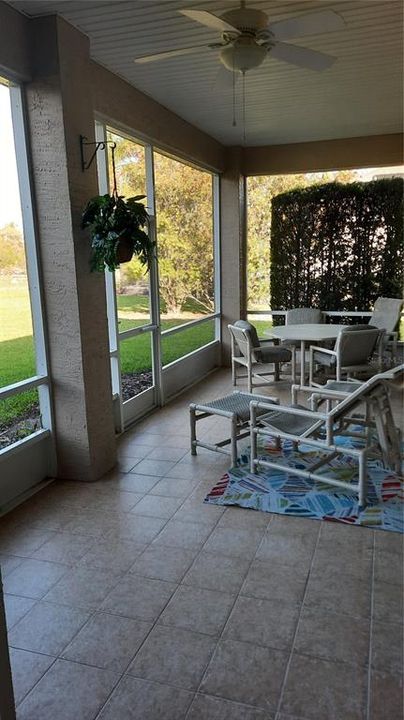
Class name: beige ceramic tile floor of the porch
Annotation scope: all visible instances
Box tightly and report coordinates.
[0,371,403,720]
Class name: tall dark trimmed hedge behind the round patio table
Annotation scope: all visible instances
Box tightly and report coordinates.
[271,178,404,318]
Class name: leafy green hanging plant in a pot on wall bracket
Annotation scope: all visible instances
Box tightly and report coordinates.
[81,147,155,272]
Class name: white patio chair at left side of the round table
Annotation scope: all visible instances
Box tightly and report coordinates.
[228,320,296,393]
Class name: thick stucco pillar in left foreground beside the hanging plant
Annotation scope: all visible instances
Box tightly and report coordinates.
[26,16,116,480]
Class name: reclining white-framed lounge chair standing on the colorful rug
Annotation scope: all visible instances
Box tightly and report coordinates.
[250,365,404,508]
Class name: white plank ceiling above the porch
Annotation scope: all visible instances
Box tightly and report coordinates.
[10,0,403,145]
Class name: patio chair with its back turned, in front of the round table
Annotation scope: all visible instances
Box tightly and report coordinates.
[309,325,380,387]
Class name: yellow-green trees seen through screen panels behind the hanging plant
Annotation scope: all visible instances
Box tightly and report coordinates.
[107,135,214,314]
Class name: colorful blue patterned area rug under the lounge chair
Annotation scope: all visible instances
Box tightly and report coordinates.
[205,437,404,533]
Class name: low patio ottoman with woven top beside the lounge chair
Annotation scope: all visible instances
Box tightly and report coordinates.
[189,392,279,467]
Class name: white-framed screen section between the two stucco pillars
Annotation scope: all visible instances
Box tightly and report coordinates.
[96,122,220,431]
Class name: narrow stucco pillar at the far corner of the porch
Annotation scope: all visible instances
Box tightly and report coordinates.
[220,147,247,365]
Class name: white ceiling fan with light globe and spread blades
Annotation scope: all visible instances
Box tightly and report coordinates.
[135,0,345,74]
